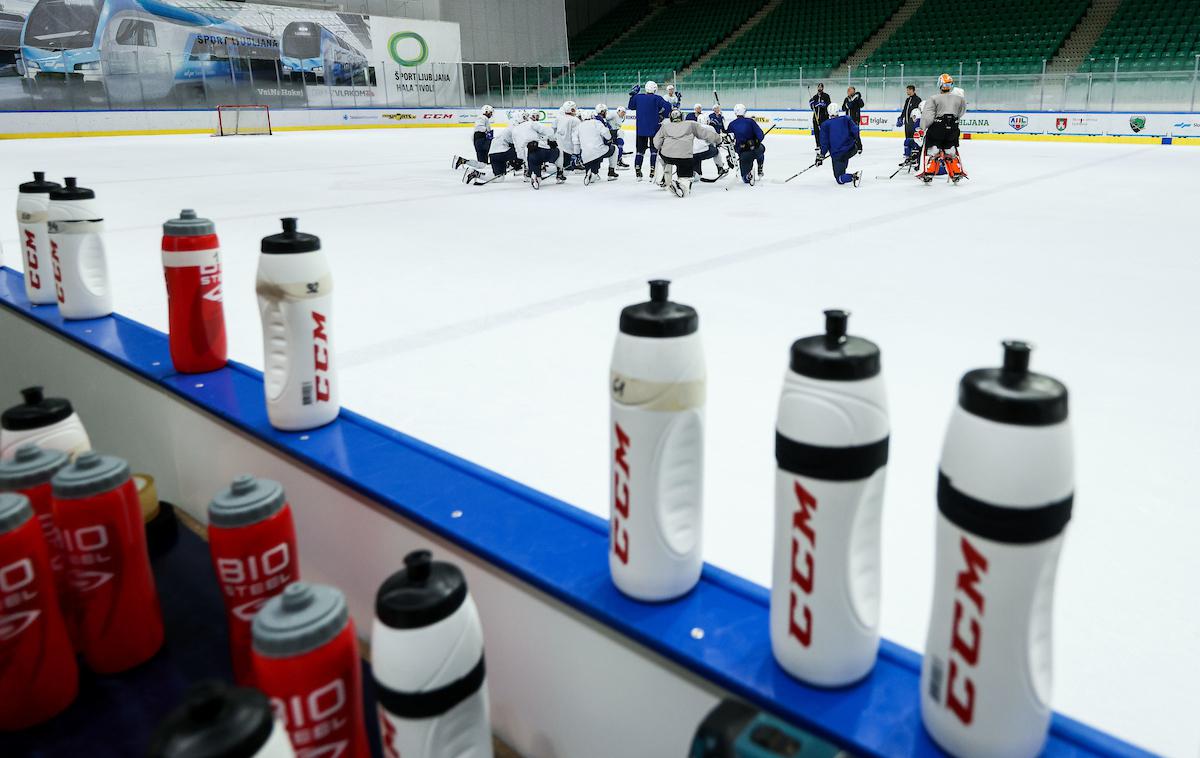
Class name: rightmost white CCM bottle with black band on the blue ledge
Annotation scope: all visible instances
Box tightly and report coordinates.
[920,342,1074,758]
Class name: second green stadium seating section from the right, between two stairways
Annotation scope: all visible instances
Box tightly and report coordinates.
[866,0,1088,76]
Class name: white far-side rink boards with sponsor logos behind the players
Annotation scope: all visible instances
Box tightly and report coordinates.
[0,108,1200,145]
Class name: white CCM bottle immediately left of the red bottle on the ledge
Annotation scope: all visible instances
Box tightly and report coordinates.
[46,176,113,319]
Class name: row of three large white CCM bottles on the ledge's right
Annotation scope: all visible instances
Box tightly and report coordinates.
[608,281,1074,758]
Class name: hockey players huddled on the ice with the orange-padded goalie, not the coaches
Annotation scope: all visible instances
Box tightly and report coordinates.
[451,74,966,198]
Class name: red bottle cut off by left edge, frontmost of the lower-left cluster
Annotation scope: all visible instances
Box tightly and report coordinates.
[0,492,79,732]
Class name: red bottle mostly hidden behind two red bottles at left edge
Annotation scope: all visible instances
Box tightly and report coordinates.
[0,445,79,650]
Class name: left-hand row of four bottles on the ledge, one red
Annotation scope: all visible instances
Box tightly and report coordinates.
[17,172,340,431]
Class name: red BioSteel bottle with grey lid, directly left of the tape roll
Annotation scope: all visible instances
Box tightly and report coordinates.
[50,451,163,674]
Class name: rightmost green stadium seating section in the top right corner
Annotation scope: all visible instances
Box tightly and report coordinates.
[1079,0,1200,72]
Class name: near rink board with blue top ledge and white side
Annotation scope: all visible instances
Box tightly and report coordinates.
[0,267,1150,758]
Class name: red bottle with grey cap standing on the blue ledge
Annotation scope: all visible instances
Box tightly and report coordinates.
[162,210,226,374]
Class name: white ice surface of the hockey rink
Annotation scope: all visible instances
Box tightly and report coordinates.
[0,130,1200,757]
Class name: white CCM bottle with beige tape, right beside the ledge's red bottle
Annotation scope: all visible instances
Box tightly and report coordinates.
[257,218,338,432]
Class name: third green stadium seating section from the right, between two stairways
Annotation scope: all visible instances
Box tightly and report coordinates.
[692,0,901,82]
